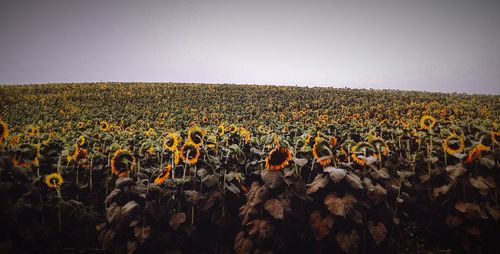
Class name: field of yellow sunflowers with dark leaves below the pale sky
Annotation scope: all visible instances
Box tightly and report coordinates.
[0,83,500,254]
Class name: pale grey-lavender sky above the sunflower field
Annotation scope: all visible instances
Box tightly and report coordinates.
[0,0,500,94]
